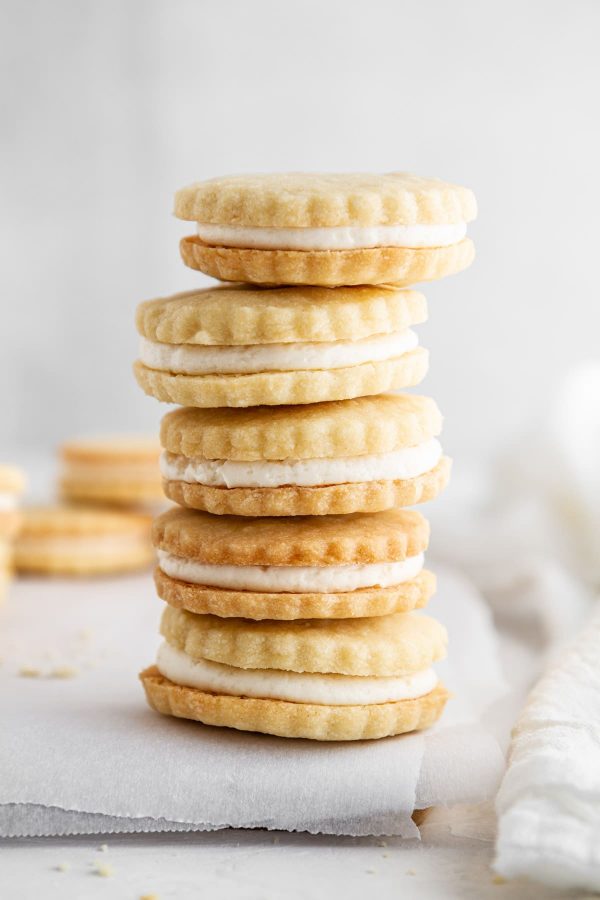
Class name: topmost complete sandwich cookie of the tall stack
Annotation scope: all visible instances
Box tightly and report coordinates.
[174,172,477,287]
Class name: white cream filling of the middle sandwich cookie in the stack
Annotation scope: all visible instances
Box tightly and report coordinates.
[160,438,442,488]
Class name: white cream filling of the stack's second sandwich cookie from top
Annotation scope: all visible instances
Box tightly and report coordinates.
[140,329,419,375]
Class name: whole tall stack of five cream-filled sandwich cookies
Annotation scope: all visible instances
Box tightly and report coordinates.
[135,173,476,740]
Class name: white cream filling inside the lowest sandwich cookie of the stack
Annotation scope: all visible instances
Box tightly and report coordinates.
[156,641,438,706]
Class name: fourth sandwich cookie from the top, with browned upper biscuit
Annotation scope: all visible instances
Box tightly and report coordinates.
[152,508,435,620]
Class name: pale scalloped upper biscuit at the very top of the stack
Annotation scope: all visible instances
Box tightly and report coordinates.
[174,172,477,228]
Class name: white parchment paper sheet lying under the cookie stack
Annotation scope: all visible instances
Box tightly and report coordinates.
[0,571,506,836]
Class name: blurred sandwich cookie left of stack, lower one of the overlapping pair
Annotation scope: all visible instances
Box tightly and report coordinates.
[15,506,154,575]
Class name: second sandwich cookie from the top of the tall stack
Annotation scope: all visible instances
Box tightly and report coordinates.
[135,286,428,407]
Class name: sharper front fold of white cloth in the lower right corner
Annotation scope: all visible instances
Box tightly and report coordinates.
[495,604,600,891]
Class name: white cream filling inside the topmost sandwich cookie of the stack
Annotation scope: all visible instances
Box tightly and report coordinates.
[197,222,467,250]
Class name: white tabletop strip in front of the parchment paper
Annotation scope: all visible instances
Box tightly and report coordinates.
[0,830,581,900]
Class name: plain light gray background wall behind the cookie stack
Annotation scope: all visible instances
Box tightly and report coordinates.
[0,0,600,457]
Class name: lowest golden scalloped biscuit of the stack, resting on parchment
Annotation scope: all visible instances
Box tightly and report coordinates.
[140,666,449,741]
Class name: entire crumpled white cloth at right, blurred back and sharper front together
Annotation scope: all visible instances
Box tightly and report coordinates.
[433,361,600,890]
